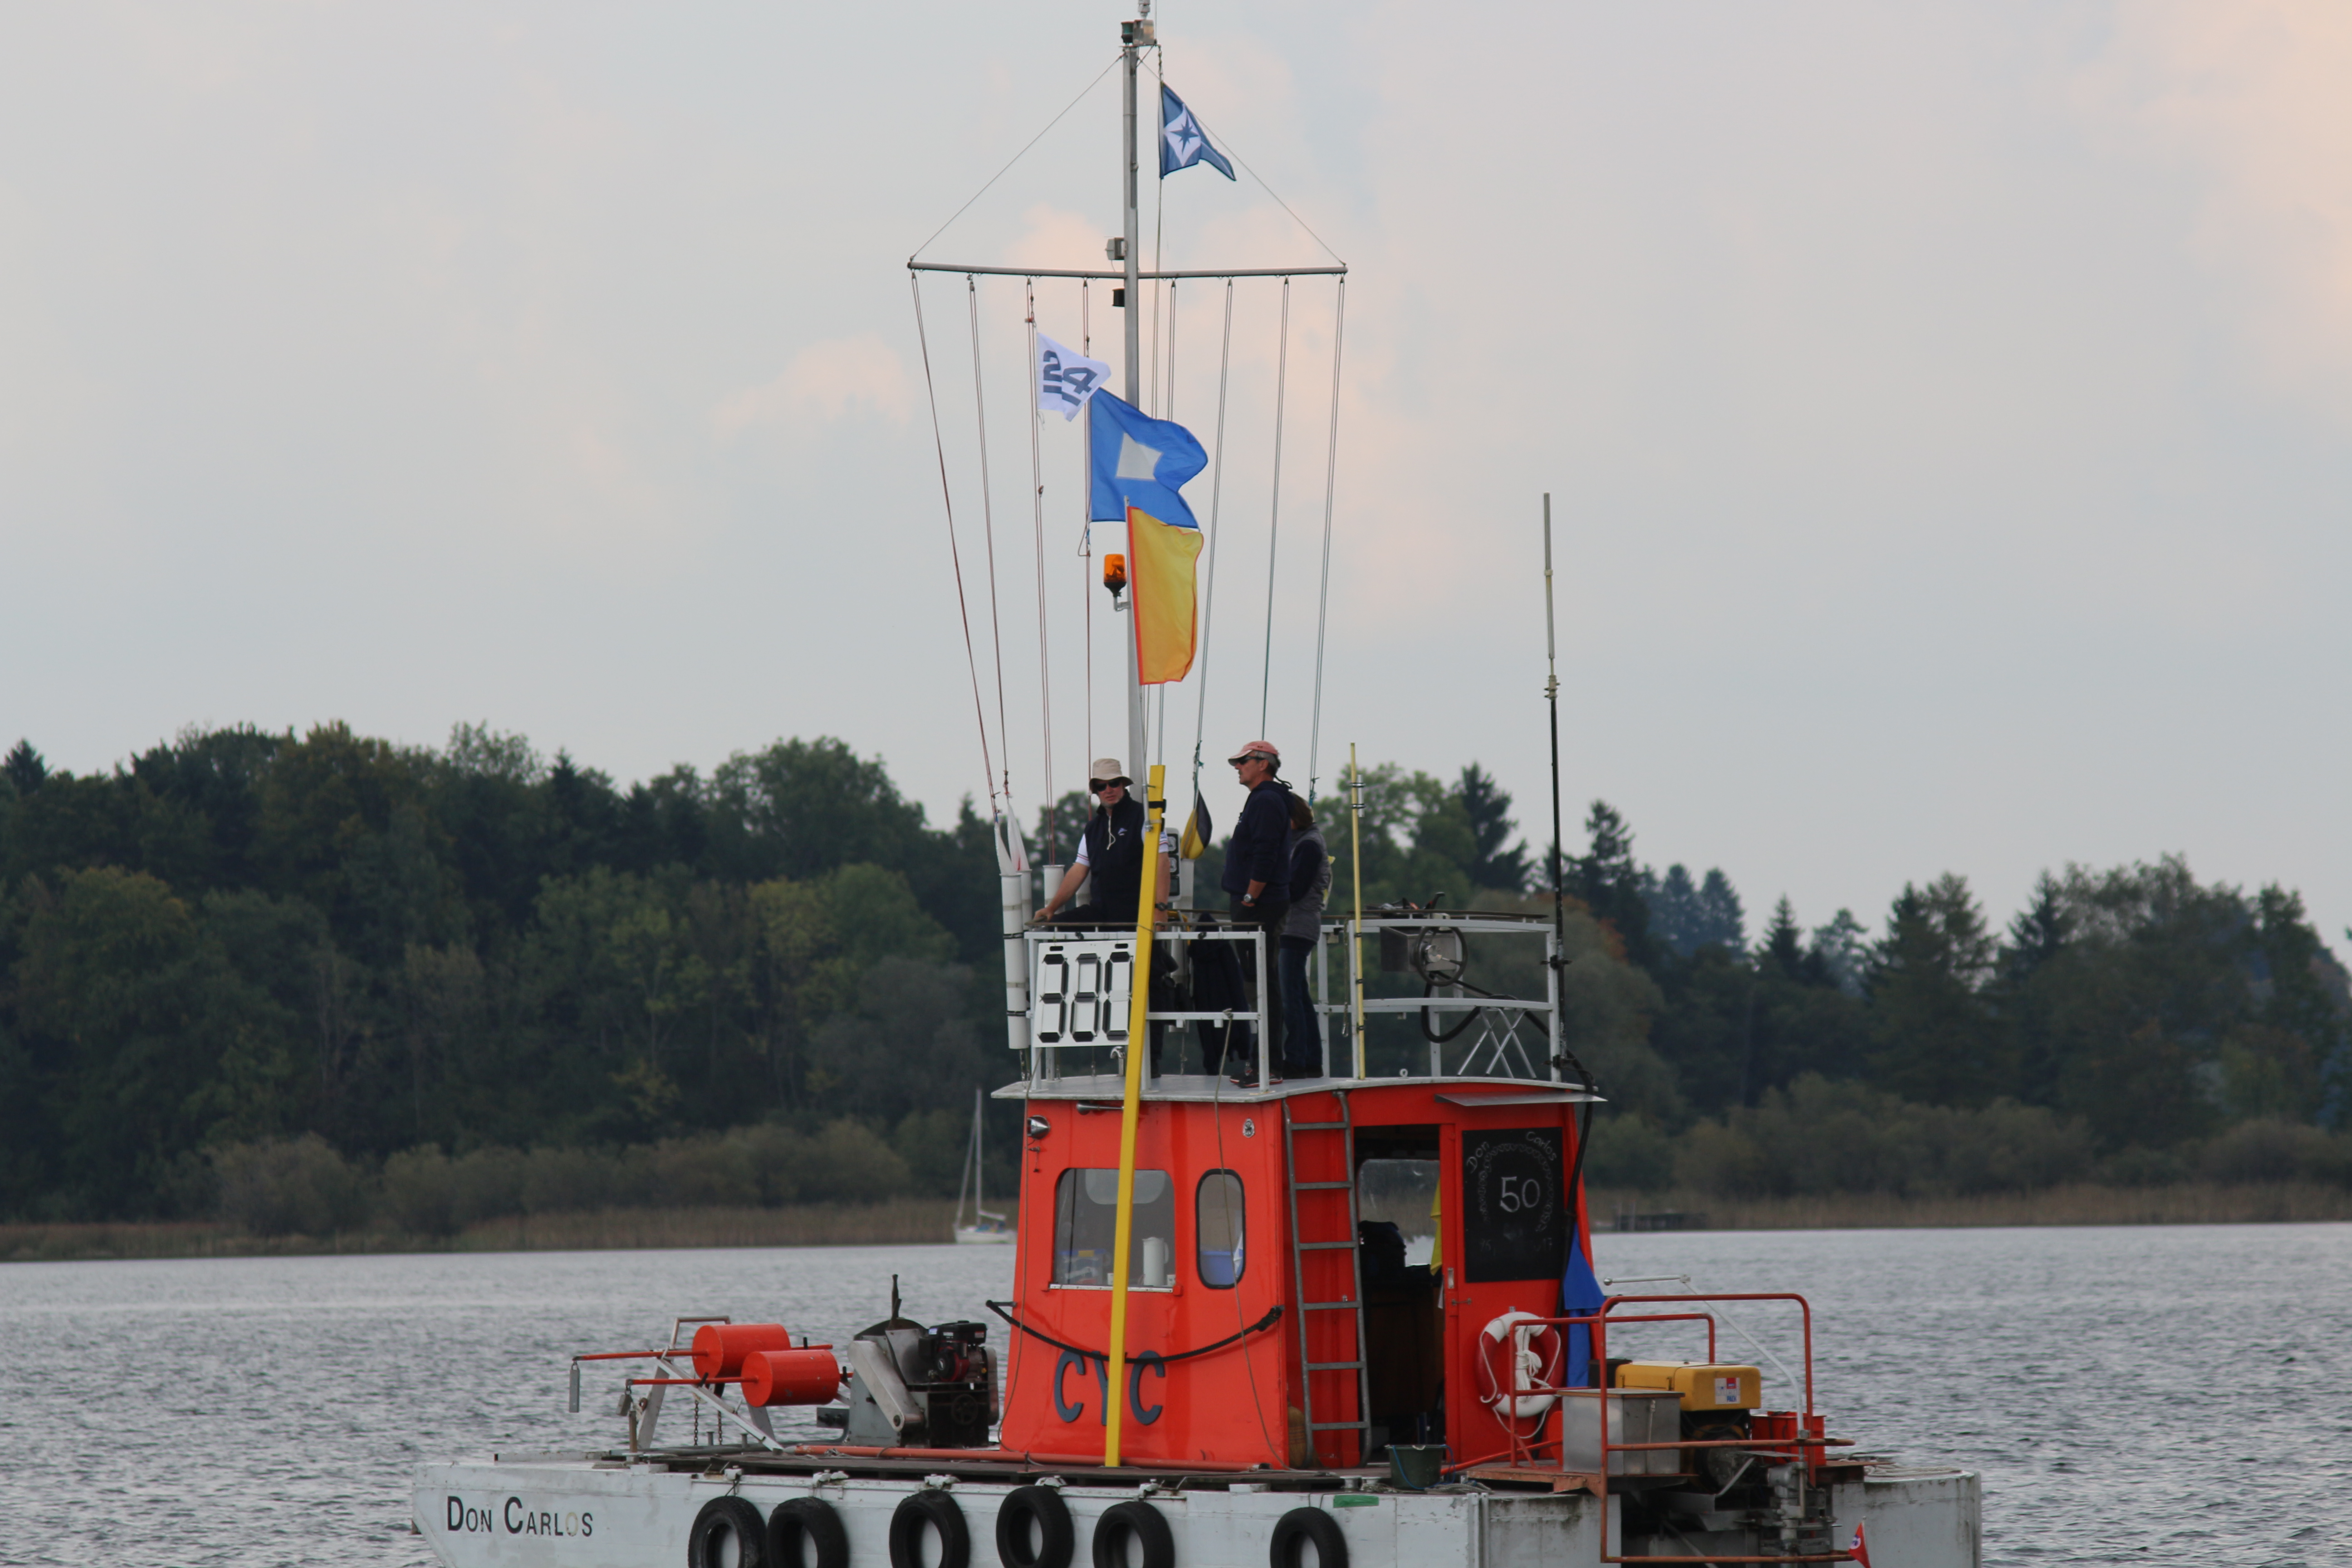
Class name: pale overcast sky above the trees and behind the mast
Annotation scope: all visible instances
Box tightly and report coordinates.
[0,0,2352,947]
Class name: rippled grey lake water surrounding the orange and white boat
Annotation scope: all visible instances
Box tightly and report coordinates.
[0,1225,2352,1568]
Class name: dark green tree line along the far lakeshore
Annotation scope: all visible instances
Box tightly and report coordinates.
[0,724,2352,1222]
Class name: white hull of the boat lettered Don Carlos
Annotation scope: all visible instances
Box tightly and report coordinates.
[416,1457,1978,1568]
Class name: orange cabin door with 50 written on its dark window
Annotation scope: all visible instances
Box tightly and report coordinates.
[1442,1107,1576,1465]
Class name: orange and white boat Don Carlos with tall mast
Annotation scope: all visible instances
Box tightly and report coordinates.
[414,12,1980,1568]
